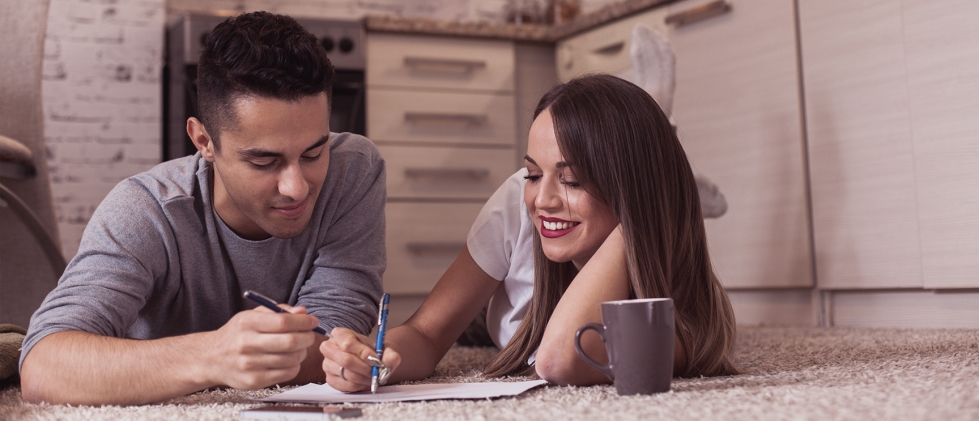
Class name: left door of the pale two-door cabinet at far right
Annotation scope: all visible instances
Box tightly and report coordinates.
[799,0,922,288]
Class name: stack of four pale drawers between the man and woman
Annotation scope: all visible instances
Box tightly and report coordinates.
[366,32,518,296]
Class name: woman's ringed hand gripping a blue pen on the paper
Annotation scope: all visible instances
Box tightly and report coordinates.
[320,327,401,392]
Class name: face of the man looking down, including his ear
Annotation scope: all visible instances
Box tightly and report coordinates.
[201,93,330,240]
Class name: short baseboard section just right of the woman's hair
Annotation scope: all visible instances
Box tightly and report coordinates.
[727,288,820,326]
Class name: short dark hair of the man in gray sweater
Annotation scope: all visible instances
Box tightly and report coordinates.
[197,12,336,148]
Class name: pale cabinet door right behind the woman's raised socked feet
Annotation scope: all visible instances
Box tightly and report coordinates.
[670,0,813,288]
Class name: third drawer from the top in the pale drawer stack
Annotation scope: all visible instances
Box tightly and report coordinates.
[377,145,517,199]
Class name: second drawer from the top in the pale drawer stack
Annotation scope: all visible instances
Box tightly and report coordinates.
[367,89,516,145]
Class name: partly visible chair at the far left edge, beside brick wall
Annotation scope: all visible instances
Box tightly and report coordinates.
[0,0,64,327]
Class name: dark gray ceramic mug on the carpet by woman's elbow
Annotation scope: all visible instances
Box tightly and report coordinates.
[574,298,676,395]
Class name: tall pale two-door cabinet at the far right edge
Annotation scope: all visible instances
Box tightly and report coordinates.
[799,0,979,289]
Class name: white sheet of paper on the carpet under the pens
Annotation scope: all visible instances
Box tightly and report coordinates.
[260,380,547,403]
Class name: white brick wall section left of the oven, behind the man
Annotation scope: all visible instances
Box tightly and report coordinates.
[42,0,166,258]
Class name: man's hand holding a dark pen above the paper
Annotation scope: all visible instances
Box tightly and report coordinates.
[202,305,319,390]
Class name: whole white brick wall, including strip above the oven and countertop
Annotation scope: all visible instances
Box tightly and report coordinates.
[43,0,616,259]
